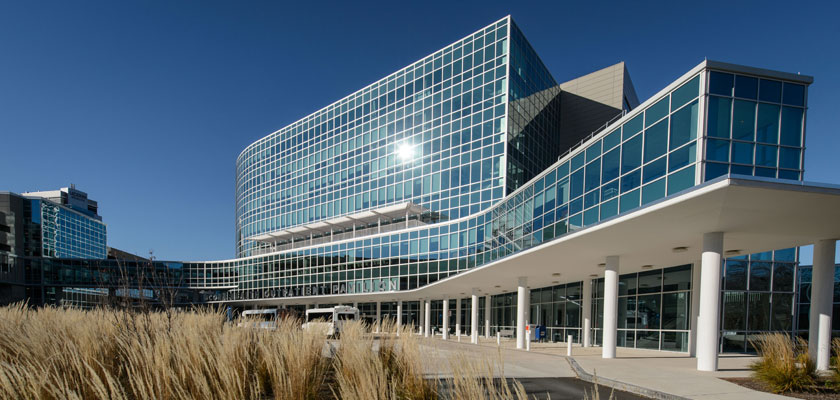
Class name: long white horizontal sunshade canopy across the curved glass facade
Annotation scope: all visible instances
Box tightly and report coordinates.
[243,201,430,243]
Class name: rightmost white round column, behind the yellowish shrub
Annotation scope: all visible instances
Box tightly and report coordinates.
[808,240,837,371]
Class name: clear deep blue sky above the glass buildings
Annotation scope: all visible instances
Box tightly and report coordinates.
[0,1,840,260]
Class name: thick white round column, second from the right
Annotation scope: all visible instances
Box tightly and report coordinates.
[695,232,723,371]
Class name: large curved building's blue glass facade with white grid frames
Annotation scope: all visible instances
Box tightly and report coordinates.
[4,17,832,360]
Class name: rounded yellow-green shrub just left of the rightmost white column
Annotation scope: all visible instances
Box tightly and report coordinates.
[750,333,816,393]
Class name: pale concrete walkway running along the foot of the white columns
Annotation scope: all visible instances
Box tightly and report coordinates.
[424,337,789,400]
